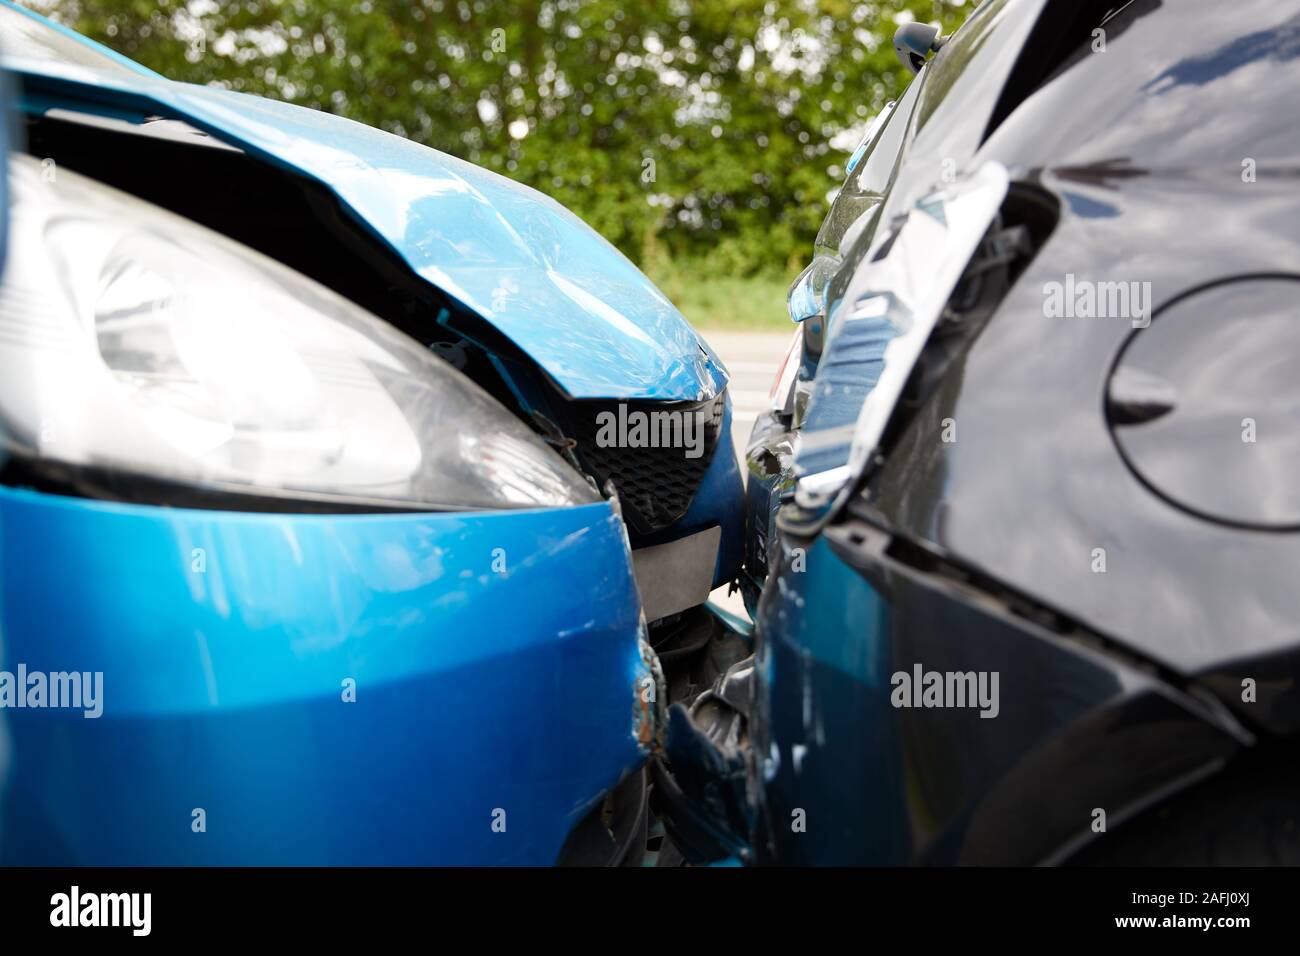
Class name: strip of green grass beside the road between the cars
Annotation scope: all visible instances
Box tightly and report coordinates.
[650,264,790,332]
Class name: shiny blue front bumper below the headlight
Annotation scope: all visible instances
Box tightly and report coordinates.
[0,488,649,865]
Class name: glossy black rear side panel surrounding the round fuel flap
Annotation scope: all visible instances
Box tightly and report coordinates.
[870,0,1300,689]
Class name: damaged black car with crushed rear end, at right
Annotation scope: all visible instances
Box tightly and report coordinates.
[657,0,1300,866]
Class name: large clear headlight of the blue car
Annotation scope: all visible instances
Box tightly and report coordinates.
[0,156,598,510]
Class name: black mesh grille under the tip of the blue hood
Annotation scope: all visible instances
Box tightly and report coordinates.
[568,393,727,535]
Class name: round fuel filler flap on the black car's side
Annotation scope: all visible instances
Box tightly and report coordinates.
[1106,276,1300,531]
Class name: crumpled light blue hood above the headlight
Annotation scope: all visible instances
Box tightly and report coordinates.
[5,52,727,401]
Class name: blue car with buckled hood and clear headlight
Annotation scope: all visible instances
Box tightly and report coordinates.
[0,3,748,865]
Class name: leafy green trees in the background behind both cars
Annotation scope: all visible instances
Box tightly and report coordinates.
[25,0,975,276]
